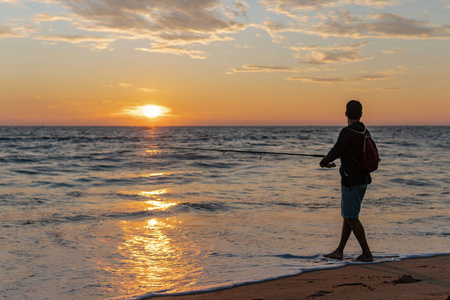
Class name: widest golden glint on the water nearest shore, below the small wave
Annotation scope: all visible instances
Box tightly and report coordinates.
[110,218,202,294]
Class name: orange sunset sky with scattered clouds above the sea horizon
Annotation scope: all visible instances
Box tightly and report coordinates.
[0,0,450,126]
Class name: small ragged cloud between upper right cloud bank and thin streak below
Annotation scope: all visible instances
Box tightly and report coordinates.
[291,42,370,65]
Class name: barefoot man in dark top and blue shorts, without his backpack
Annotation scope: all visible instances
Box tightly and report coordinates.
[320,100,373,262]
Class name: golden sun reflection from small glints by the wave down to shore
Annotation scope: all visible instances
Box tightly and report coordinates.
[98,188,203,295]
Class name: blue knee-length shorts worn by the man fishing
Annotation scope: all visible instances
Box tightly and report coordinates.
[341,184,367,219]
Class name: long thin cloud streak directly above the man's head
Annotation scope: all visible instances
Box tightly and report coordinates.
[287,66,407,83]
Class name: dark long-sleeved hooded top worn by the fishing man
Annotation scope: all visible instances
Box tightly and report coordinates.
[320,122,372,187]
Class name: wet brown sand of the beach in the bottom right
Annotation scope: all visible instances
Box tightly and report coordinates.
[148,255,450,300]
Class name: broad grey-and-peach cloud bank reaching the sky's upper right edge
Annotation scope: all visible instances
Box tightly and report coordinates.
[252,5,450,42]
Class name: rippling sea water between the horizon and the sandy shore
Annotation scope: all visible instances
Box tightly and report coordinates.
[0,127,450,299]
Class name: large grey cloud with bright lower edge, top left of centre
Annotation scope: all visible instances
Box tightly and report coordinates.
[55,0,247,58]
